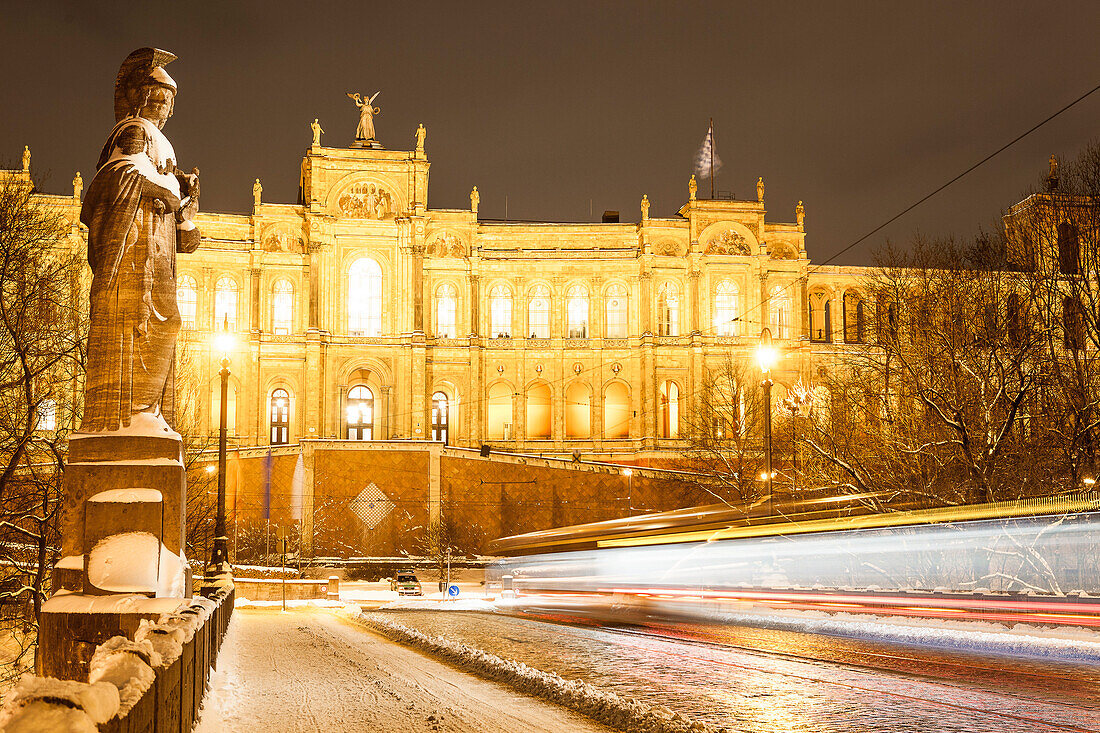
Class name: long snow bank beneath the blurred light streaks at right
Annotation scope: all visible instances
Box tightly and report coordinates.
[710,611,1100,665]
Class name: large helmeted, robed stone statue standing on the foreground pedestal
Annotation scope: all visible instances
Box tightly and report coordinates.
[80,48,199,431]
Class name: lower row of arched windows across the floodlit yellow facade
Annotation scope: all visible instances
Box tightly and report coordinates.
[258,381,680,446]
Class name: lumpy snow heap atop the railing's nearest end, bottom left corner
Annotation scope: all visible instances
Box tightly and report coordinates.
[0,675,119,733]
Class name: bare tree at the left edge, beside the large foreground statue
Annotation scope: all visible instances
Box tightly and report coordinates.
[0,171,85,686]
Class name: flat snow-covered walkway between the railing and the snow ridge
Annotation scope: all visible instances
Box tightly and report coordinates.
[196,609,608,733]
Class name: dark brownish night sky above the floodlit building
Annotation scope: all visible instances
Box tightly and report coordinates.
[0,0,1100,263]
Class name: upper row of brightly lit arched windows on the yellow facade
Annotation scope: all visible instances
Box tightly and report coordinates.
[176,258,805,339]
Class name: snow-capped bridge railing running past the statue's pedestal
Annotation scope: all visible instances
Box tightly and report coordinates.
[0,584,234,733]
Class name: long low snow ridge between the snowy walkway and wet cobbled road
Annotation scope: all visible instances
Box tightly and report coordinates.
[349,605,721,733]
